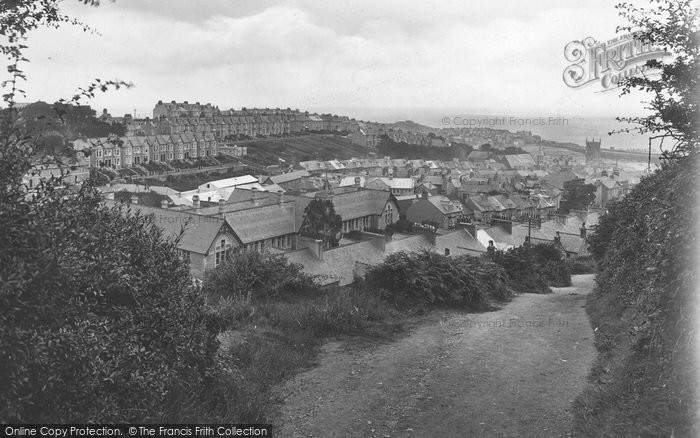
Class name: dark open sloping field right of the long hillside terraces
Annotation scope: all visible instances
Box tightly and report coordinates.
[241,135,369,165]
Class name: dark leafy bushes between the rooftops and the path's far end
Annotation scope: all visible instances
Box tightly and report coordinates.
[367,244,571,310]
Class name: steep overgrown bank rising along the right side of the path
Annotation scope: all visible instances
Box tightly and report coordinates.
[575,157,700,436]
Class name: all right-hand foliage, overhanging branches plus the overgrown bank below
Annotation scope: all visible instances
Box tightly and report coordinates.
[575,0,700,436]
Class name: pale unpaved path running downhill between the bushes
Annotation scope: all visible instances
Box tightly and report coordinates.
[275,275,596,437]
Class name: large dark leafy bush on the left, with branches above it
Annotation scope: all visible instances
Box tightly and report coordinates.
[0,0,219,423]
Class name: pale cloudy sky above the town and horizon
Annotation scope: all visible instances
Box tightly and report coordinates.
[17,0,660,118]
